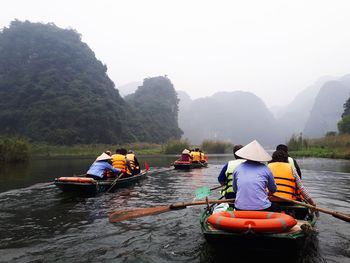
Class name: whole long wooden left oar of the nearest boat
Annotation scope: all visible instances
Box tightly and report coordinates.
[109,199,235,223]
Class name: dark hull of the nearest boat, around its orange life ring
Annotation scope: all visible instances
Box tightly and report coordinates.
[200,205,317,251]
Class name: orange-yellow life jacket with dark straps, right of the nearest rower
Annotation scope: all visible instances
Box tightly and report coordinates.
[268,162,299,201]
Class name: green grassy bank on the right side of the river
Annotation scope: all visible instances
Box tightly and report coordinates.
[288,134,350,159]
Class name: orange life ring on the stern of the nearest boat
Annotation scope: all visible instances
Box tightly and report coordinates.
[208,211,297,233]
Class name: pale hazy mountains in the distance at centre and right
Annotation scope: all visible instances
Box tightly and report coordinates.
[119,75,350,146]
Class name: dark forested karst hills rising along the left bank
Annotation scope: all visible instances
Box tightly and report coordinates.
[0,20,180,144]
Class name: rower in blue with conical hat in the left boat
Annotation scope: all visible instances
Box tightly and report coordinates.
[86,153,123,180]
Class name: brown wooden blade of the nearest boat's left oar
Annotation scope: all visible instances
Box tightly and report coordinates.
[109,205,170,223]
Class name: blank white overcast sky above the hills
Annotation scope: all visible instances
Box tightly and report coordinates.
[0,0,350,107]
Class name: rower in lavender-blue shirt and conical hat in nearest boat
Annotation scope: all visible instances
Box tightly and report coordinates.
[232,140,280,212]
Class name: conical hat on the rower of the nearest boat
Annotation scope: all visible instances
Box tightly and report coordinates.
[236,140,272,162]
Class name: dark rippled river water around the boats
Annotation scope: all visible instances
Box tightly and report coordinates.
[0,155,350,262]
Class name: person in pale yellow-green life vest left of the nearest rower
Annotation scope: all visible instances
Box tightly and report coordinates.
[218,144,245,199]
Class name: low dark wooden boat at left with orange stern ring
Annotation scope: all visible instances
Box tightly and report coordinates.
[54,170,147,196]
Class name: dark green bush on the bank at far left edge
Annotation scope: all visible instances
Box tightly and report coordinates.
[0,137,29,163]
